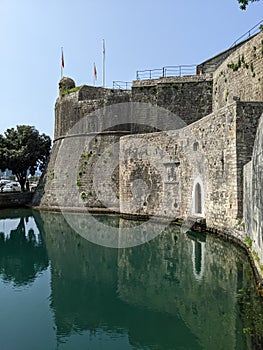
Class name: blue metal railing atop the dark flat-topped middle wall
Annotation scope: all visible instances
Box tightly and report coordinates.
[136,65,196,80]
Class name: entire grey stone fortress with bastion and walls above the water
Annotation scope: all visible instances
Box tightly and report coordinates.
[34,32,263,274]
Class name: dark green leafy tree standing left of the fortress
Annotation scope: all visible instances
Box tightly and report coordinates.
[0,125,51,191]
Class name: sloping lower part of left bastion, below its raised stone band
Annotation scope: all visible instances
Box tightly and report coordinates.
[35,132,128,209]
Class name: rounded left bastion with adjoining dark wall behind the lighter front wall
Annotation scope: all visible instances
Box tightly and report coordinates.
[39,76,212,208]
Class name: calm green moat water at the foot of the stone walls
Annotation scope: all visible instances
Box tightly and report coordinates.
[0,210,263,350]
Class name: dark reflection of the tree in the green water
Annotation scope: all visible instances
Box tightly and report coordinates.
[0,217,48,286]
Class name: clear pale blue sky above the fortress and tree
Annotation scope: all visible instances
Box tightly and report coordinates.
[0,0,263,138]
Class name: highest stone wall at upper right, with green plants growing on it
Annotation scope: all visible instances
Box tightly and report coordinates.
[213,32,263,110]
